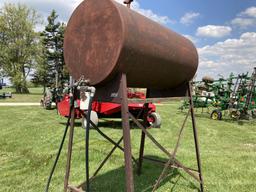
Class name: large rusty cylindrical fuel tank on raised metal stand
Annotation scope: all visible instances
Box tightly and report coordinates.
[64,0,198,89]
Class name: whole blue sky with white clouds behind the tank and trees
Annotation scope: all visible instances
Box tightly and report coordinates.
[0,0,256,79]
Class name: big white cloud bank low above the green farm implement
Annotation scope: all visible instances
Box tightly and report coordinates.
[198,32,256,77]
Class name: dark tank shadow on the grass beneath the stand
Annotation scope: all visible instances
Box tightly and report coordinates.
[81,156,199,192]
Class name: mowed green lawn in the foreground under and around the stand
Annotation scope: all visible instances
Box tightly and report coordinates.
[0,102,256,192]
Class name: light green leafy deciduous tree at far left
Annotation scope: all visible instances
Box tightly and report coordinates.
[0,4,40,93]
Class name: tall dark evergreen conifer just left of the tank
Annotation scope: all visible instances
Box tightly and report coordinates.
[33,10,68,90]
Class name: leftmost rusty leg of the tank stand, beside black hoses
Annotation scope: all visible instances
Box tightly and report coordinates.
[64,108,75,192]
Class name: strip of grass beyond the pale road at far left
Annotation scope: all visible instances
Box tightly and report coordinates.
[0,87,43,103]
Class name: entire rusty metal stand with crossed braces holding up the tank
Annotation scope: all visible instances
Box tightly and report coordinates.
[64,74,204,192]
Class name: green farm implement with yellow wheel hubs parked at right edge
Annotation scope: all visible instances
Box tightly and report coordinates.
[180,68,256,120]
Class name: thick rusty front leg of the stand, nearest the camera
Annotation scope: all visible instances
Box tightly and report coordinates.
[120,74,134,192]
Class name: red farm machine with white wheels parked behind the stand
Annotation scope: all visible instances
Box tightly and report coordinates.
[57,92,161,128]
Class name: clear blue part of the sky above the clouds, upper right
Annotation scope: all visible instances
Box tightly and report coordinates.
[138,0,256,47]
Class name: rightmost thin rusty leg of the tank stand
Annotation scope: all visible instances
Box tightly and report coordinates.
[188,82,204,192]
